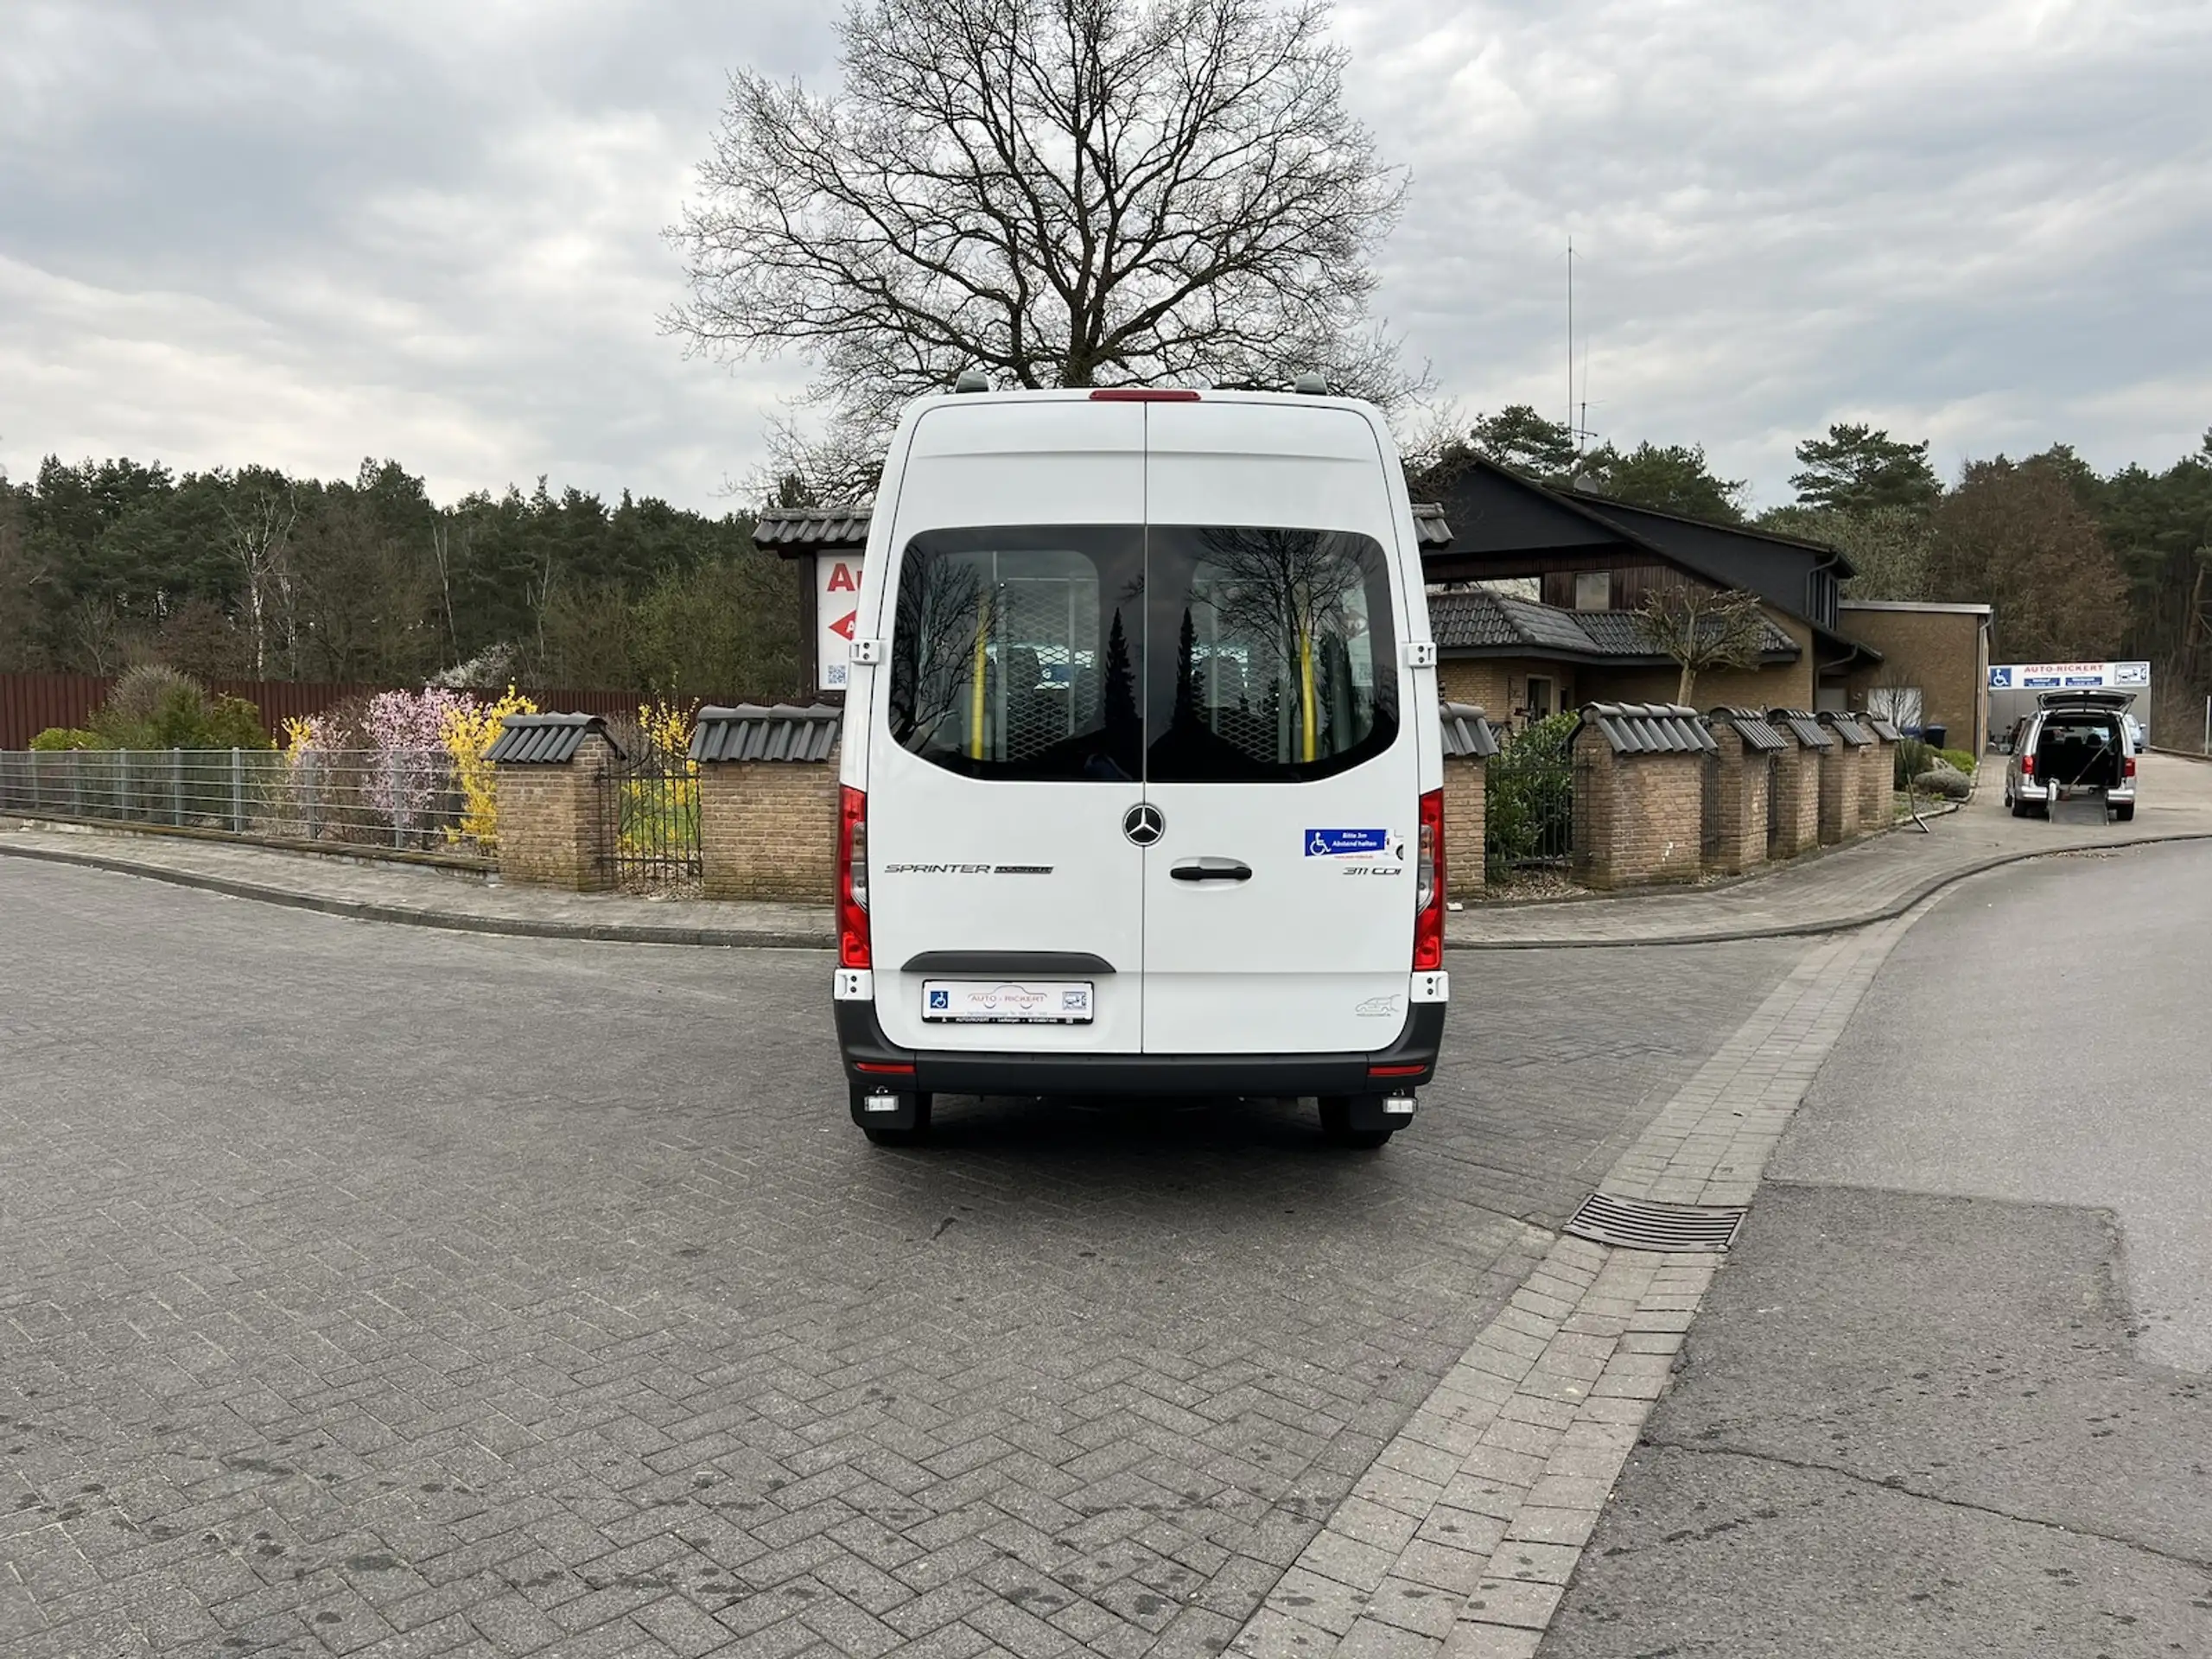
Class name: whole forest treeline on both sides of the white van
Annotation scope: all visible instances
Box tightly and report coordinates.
[0,416,2212,716]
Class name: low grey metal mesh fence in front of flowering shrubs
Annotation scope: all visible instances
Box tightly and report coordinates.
[0,750,491,854]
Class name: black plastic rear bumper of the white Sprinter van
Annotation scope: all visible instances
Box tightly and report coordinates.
[834,1002,1449,1095]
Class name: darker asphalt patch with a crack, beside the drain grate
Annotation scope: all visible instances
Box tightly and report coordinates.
[1541,1184,2212,1659]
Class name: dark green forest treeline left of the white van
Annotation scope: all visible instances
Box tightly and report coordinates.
[0,458,798,699]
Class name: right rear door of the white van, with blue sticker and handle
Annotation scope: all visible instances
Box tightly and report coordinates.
[1144,398,1421,1053]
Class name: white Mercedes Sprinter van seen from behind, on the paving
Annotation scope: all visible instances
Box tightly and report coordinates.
[836,390,1449,1146]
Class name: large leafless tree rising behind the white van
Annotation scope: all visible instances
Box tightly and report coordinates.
[668,0,1411,491]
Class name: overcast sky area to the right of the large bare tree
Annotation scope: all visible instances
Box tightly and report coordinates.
[1343,0,2212,500]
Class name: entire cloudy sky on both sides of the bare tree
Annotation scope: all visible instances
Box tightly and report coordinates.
[0,0,2212,511]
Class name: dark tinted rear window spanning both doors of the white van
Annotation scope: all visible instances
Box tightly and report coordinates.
[887,524,1398,783]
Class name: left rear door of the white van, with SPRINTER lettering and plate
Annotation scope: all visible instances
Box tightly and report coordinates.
[868,398,1144,1053]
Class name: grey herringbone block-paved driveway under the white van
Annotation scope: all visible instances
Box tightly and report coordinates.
[0,865,1801,1659]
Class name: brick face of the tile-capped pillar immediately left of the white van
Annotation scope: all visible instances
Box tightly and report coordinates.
[699,757,838,905]
